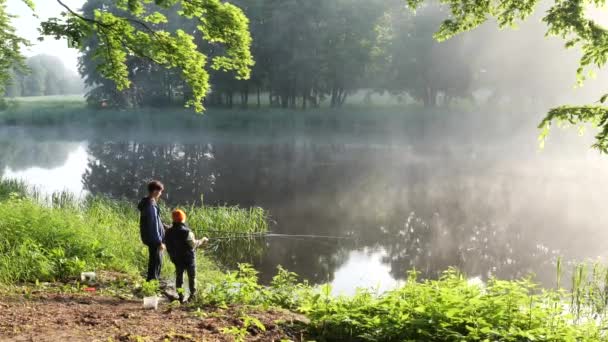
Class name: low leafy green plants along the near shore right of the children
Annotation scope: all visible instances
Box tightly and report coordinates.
[194,265,608,342]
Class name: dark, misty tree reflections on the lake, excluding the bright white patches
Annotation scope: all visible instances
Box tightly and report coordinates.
[79,143,608,288]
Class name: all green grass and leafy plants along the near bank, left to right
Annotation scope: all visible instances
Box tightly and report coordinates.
[0,180,608,341]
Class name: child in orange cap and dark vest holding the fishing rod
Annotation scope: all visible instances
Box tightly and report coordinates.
[165,209,208,302]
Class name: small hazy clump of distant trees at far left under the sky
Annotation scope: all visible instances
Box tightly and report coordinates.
[4,55,84,97]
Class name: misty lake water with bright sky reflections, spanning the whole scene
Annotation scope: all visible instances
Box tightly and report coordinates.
[0,119,608,293]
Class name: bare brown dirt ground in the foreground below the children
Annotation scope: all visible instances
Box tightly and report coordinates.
[0,294,304,342]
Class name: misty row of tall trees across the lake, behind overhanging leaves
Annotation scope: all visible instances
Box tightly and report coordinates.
[80,0,596,108]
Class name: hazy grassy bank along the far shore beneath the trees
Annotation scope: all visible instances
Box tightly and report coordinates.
[0,98,542,140]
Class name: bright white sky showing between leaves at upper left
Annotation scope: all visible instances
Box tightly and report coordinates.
[7,0,85,71]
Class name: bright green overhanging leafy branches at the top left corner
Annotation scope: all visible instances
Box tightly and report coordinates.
[0,0,254,112]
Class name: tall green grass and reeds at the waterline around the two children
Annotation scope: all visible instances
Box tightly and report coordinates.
[0,180,267,284]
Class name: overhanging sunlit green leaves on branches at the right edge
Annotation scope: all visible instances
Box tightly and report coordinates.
[407,0,608,153]
